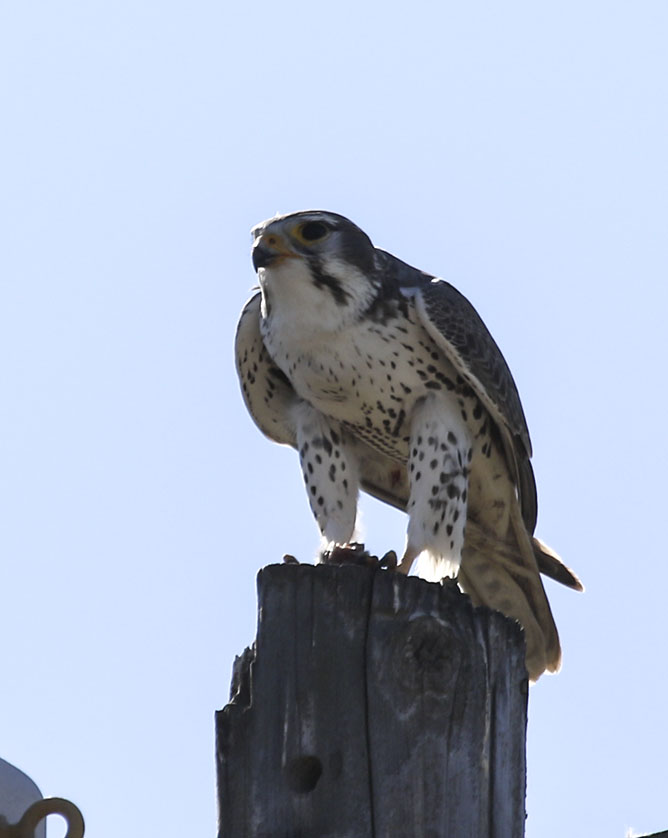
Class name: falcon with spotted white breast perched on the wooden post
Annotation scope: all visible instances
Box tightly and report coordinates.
[236,211,582,680]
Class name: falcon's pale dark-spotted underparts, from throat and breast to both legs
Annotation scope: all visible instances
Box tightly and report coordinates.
[260,258,484,581]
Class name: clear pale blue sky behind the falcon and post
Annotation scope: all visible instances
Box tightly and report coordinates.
[0,0,668,838]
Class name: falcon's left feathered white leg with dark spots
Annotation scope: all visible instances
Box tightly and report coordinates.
[294,402,359,545]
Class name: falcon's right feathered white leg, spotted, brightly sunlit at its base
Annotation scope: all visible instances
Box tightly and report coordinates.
[406,393,472,581]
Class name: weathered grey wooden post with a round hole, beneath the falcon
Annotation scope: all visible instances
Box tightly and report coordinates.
[216,565,527,838]
